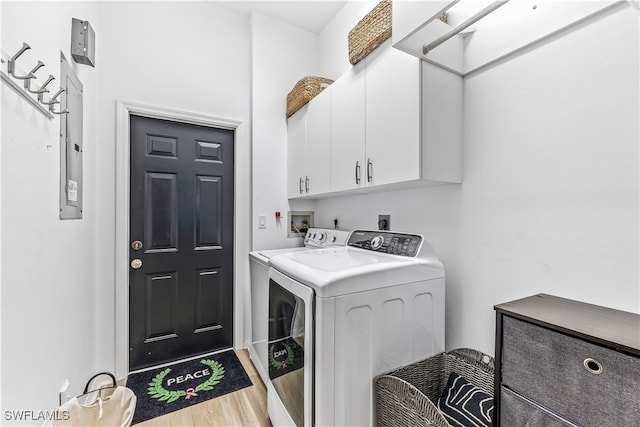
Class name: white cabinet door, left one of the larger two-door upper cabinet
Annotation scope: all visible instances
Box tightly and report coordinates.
[331,61,366,191]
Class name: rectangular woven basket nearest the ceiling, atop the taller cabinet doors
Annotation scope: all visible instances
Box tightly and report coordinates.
[348,0,391,65]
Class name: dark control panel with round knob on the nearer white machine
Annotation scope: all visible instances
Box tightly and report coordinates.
[347,230,422,257]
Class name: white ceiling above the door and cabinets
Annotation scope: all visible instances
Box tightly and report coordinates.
[212,0,346,34]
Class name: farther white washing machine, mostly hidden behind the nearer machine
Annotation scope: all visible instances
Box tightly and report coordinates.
[249,228,349,384]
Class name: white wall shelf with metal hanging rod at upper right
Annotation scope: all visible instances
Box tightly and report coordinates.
[392,0,631,76]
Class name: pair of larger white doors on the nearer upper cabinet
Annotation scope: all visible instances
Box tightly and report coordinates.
[331,42,420,191]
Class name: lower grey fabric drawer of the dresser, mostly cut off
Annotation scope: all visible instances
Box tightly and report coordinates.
[500,387,575,427]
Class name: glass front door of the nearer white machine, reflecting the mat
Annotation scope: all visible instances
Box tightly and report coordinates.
[267,268,314,426]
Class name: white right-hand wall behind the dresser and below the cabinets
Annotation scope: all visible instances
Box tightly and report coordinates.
[316,6,640,354]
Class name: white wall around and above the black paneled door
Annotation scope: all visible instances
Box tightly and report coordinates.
[95,2,250,378]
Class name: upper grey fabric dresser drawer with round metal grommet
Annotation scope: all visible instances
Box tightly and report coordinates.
[501,316,640,427]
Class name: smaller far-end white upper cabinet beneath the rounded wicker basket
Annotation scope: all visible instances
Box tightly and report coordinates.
[287,88,331,199]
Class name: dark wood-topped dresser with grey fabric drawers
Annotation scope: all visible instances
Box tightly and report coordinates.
[494,294,640,427]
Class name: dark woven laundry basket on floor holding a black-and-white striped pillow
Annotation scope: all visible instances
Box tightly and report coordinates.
[374,348,494,427]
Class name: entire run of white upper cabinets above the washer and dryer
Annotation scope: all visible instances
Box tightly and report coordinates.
[288,40,462,198]
